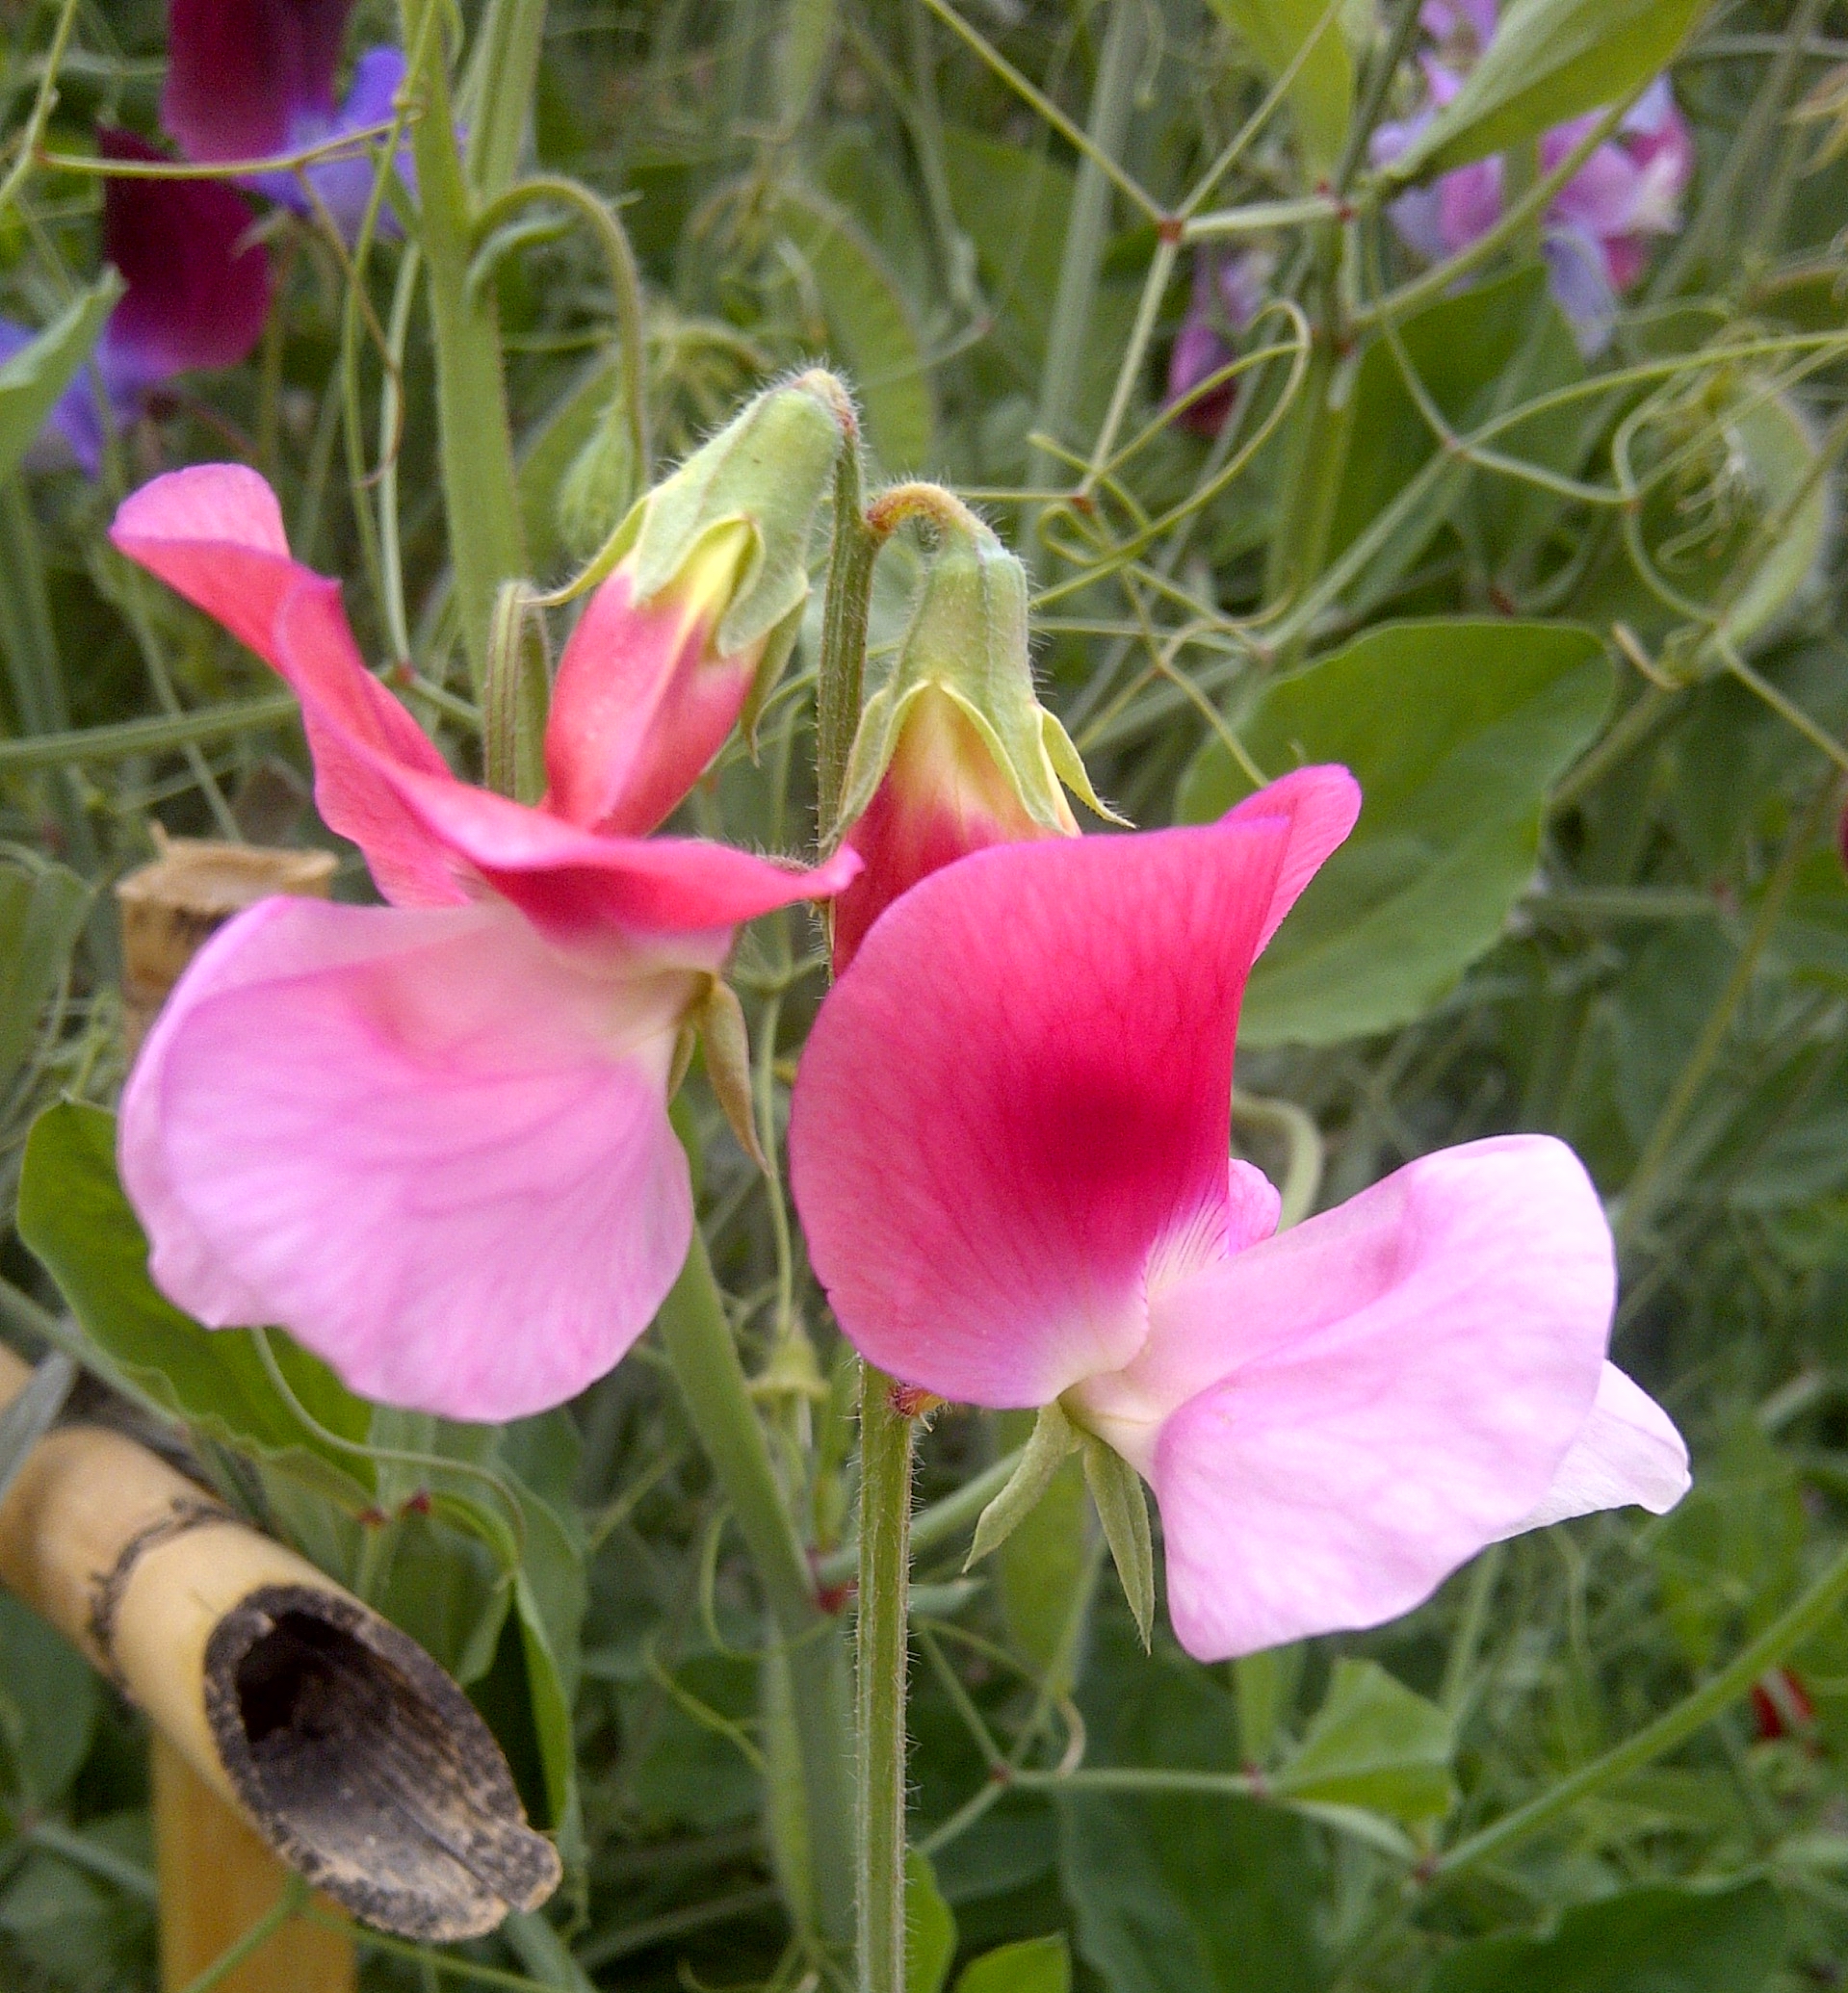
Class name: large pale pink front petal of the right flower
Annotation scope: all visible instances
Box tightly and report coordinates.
[1124,1136,1615,1660]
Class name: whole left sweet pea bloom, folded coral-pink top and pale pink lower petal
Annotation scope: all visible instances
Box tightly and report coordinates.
[112,464,857,1419]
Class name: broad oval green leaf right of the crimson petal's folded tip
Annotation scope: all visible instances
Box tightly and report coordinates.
[1176,620,1611,1047]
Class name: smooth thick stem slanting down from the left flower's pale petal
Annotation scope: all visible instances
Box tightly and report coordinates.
[660,1229,853,1943]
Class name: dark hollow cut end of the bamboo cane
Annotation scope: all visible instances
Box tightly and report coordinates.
[205,1585,560,1943]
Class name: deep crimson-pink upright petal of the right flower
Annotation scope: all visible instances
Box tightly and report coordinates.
[790,791,1294,1405]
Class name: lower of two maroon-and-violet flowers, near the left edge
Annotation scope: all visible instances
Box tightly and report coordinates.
[0,130,269,479]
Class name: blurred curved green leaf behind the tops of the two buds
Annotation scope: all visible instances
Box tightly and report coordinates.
[773,186,937,473]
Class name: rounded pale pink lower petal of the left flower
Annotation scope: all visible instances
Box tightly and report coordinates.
[121,899,695,1419]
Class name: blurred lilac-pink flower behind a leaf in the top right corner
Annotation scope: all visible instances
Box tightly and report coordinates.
[1373,0,1695,354]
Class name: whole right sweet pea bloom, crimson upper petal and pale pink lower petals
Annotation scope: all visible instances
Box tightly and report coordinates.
[790,767,1686,1660]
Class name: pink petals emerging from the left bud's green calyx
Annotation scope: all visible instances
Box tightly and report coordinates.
[546,566,758,837]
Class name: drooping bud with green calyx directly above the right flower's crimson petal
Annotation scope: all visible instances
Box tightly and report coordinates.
[833,498,1110,971]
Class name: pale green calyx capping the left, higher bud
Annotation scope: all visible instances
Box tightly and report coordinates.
[626,371,842,658]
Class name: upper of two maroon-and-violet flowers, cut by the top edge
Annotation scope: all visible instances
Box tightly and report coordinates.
[162,0,410,241]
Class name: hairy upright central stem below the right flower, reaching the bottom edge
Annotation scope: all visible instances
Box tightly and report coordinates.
[855,1363,911,1993]
